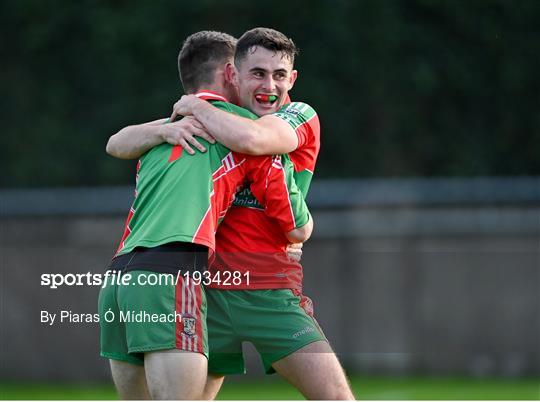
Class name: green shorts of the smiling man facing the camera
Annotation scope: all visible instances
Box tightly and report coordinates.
[206,288,326,375]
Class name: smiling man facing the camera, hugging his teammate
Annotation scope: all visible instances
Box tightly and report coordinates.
[108,28,354,399]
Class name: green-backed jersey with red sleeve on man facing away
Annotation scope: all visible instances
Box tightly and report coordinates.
[117,91,309,255]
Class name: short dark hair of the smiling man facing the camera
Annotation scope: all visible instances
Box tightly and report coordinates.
[234,28,298,66]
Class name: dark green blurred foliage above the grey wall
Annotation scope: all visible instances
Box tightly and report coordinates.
[0,0,540,187]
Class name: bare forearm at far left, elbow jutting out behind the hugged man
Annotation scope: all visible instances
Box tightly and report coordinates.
[106,119,166,159]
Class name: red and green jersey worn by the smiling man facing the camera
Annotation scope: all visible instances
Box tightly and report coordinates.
[211,102,320,290]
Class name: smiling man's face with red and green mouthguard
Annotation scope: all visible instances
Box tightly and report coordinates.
[235,46,297,116]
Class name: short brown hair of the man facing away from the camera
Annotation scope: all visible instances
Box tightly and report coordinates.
[178,31,236,94]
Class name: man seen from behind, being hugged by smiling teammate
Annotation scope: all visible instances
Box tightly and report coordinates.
[98,32,312,399]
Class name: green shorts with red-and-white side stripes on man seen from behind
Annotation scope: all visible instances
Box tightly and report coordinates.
[98,270,208,365]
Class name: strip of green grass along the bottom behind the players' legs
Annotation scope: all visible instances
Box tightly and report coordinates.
[0,377,540,400]
